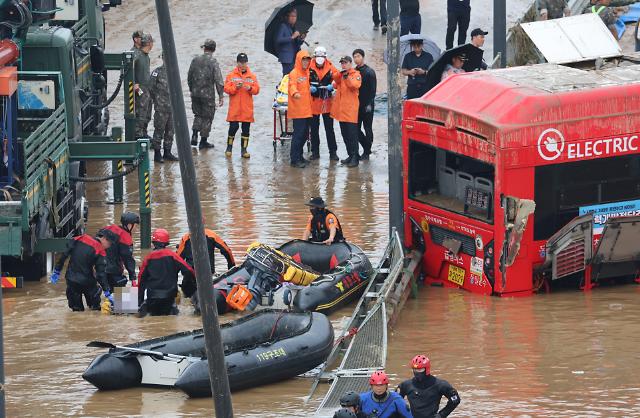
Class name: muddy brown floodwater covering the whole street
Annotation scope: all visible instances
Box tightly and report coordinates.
[3,0,640,417]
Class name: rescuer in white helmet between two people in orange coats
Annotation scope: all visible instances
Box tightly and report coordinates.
[309,46,339,161]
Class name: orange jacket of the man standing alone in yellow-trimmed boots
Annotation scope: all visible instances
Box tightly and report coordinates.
[224,67,260,122]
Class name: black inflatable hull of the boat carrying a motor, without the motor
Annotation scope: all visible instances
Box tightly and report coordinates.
[215,240,373,314]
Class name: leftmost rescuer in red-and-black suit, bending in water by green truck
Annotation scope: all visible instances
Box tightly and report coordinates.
[50,229,118,312]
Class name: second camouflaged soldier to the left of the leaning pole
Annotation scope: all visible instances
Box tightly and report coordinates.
[133,33,153,139]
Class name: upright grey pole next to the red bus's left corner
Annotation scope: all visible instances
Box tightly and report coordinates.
[387,0,404,237]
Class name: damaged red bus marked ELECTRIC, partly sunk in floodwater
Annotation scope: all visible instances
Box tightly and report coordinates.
[402,60,640,296]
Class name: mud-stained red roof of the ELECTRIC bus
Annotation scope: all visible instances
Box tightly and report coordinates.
[404,56,640,136]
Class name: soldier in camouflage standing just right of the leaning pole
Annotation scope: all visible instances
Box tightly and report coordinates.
[187,39,224,149]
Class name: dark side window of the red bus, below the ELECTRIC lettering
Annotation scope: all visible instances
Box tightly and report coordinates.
[533,155,640,241]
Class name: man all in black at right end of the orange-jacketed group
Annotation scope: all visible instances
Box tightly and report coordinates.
[353,49,377,160]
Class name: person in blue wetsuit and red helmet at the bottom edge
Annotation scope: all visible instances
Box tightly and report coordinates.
[360,371,413,418]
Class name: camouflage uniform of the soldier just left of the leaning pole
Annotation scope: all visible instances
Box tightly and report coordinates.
[150,65,173,152]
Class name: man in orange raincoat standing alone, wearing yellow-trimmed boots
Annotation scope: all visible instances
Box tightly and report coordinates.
[224,53,260,158]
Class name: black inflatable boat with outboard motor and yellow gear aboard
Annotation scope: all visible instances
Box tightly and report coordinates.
[215,240,373,314]
